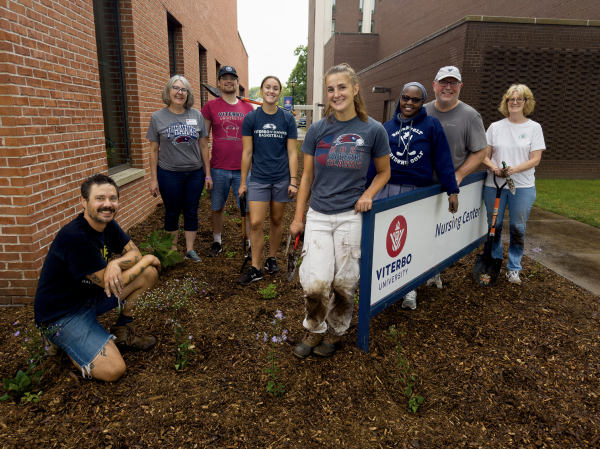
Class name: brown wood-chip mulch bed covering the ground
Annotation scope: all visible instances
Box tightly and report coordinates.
[0,157,600,449]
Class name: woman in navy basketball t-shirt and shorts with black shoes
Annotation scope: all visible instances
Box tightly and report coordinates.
[238,76,298,285]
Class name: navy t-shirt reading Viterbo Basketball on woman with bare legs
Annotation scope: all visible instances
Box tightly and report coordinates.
[242,107,298,184]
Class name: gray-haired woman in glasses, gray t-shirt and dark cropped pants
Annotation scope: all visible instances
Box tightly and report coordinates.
[146,75,212,262]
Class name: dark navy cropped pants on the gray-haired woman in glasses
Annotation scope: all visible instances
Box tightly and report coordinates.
[156,167,206,232]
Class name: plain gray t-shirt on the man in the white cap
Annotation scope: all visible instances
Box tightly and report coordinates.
[425,101,487,171]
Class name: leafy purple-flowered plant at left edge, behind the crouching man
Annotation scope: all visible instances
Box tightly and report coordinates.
[0,321,60,402]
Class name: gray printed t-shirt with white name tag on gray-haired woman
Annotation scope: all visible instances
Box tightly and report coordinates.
[146,107,208,171]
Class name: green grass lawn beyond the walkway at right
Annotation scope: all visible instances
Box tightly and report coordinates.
[533,179,600,228]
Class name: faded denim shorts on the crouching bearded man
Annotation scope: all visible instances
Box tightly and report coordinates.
[47,291,119,377]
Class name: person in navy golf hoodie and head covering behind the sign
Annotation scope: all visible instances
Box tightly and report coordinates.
[367,82,459,309]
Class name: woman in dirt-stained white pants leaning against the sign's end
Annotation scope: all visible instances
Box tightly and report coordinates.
[290,64,390,359]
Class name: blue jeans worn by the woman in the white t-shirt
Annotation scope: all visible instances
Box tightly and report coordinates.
[483,186,535,271]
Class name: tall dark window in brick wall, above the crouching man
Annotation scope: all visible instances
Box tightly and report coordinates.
[93,0,131,174]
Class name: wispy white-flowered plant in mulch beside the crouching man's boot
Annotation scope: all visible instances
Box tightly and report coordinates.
[135,277,199,371]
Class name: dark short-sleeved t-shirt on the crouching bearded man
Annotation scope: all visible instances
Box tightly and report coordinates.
[34,214,131,324]
